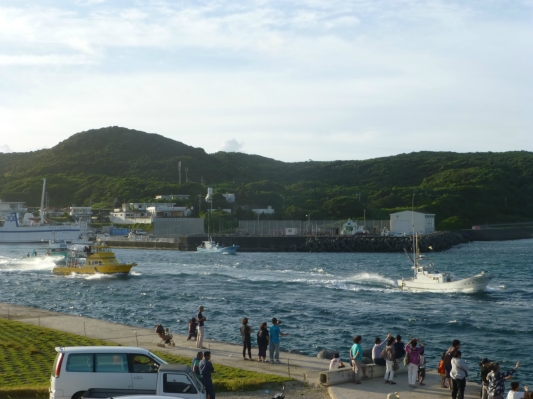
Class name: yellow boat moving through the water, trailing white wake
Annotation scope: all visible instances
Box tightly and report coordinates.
[52,244,137,276]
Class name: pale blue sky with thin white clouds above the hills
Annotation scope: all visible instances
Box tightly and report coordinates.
[0,0,533,162]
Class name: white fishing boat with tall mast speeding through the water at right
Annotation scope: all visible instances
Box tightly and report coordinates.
[398,238,492,293]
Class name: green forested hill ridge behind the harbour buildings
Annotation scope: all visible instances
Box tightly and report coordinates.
[0,127,533,227]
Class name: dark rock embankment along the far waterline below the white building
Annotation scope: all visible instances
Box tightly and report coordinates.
[291,231,468,252]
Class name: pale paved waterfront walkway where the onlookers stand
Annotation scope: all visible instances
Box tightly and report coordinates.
[0,303,479,399]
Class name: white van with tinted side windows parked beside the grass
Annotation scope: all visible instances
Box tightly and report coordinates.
[50,346,167,399]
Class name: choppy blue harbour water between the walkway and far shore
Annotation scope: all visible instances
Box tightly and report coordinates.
[0,240,533,384]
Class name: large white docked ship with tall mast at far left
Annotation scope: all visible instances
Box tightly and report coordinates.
[0,179,88,243]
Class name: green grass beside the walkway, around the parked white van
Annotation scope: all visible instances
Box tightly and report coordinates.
[0,319,289,399]
